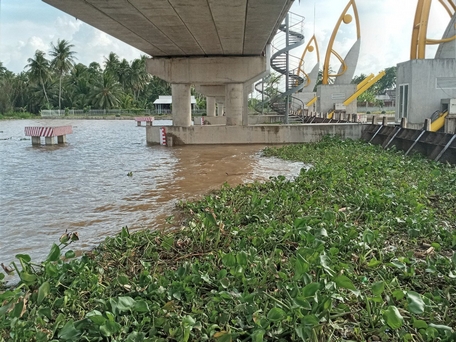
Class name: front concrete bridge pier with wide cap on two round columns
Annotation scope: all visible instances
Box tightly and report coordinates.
[147,56,269,127]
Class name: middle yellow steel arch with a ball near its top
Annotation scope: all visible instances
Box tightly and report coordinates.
[322,0,361,84]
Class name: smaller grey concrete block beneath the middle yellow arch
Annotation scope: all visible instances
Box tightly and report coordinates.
[317,84,358,114]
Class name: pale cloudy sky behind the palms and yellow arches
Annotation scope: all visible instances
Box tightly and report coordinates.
[0,0,450,75]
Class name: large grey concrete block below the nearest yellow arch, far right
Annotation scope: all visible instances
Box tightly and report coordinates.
[396,58,456,125]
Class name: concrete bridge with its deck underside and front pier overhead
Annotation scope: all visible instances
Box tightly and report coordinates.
[43,0,294,127]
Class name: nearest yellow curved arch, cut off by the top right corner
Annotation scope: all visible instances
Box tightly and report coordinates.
[410,0,456,59]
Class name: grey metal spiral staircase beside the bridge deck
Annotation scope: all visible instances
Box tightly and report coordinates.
[255,13,306,123]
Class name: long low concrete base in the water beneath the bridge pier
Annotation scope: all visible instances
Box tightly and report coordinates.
[146,123,363,145]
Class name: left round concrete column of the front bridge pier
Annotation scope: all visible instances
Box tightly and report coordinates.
[171,83,192,127]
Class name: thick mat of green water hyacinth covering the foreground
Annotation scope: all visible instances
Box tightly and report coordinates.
[0,139,456,342]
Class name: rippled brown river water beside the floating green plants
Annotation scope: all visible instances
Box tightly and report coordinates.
[0,119,303,280]
